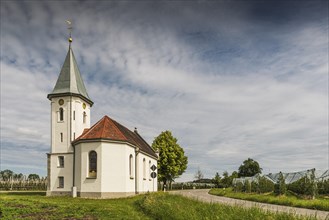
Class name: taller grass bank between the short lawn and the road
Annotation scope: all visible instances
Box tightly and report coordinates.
[137,192,315,220]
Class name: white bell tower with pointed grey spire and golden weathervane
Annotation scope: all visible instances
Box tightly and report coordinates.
[47,24,93,195]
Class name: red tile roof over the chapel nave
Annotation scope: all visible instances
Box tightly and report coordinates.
[72,115,157,158]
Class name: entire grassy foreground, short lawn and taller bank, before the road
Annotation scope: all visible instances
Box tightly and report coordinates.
[0,192,315,220]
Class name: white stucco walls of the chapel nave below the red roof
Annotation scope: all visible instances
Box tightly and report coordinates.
[75,142,157,193]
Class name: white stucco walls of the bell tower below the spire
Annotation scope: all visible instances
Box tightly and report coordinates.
[49,96,90,194]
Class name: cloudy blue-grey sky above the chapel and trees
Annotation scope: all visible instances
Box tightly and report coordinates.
[0,0,329,181]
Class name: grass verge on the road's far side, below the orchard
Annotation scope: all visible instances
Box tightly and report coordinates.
[209,188,329,211]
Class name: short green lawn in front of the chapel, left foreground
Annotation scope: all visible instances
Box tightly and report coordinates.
[0,192,148,219]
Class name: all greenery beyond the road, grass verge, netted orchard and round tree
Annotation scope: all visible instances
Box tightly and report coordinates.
[209,158,329,211]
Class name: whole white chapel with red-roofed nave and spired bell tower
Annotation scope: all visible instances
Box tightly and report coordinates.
[47,38,158,198]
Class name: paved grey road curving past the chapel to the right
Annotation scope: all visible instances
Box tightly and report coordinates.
[170,189,329,220]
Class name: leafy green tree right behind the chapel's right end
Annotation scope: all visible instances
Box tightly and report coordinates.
[152,131,188,188]
